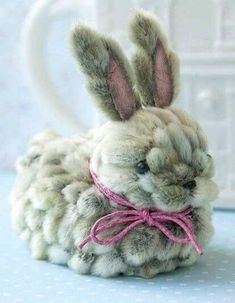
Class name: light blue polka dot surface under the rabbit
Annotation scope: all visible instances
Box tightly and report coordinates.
[0,174,235,303]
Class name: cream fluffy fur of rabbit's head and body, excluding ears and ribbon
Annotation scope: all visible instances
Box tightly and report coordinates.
[12,108,217,277]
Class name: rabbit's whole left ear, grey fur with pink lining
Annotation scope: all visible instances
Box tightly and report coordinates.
[71,24,139,120]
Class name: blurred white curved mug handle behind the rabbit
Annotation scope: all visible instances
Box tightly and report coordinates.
[22,0,86,133]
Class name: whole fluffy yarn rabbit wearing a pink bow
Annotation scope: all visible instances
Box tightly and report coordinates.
[12,11,217,278]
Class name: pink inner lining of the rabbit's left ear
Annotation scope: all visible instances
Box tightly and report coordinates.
[108,58,136,120]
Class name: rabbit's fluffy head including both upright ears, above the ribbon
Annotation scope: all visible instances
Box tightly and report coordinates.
[72,11,217,211]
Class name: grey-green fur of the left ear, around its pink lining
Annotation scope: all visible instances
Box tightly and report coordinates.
[71,24,139,120]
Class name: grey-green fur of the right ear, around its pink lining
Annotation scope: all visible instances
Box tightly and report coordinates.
[129,11,179,106]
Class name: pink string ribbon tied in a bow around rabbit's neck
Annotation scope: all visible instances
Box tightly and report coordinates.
[76,170,203,255]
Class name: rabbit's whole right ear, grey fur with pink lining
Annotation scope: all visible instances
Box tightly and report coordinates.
[130,11,179,107]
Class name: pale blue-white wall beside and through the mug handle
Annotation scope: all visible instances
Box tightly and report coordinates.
[0,0,97,170]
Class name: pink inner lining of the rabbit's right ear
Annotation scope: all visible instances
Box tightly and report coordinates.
[154,42,173,107]
